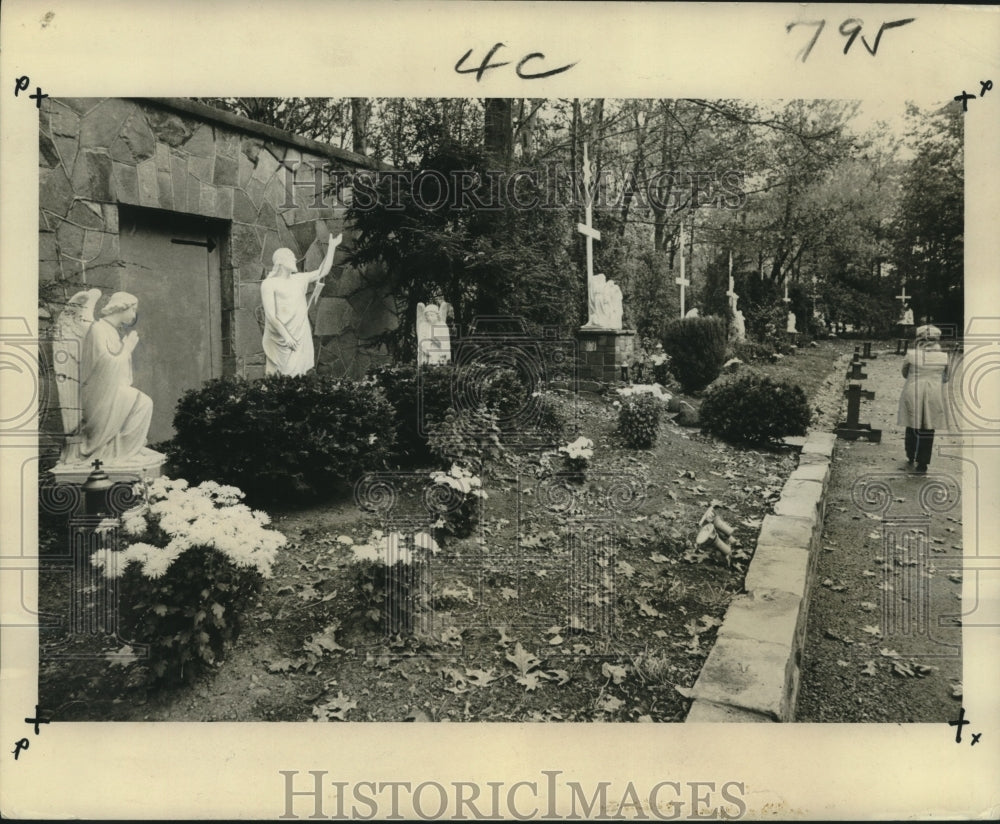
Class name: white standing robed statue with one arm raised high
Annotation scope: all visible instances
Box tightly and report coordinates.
[260,235,342,375]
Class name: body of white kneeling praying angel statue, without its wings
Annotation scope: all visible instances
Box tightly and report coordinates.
[78,292,153,463]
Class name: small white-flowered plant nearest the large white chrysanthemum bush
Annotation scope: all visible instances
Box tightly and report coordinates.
[338,529,440,636]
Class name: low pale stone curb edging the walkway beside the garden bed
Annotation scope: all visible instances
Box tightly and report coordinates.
[685,432,836,723]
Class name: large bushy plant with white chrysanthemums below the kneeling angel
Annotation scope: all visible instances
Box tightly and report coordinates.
[91,478,286,681]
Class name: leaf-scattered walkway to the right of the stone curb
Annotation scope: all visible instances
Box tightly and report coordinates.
[795,344,962,722]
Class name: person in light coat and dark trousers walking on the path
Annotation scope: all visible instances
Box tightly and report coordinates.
[896,325,948,474]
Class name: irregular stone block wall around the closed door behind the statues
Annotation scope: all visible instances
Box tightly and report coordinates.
[39,98,398,384]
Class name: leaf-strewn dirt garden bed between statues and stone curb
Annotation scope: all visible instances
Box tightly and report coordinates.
[39,342,853,721]
